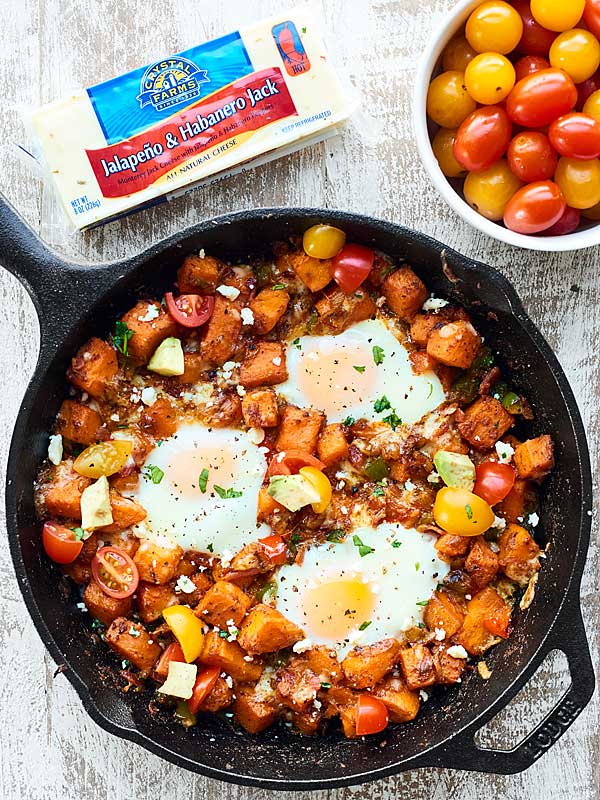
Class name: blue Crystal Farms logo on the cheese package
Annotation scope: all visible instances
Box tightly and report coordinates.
[136,57,210,111]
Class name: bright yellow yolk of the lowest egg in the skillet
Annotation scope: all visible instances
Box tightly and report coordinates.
[302,577,375,641]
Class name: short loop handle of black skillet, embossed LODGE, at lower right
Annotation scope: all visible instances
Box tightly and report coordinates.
[429,600,595,775]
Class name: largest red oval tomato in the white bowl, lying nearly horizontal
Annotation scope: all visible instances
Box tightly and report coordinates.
[506,69,577,128]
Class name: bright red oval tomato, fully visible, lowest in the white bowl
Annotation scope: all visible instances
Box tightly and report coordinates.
[504,181,567,234]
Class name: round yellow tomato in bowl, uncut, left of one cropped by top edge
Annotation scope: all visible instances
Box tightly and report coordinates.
[465,0,523,54]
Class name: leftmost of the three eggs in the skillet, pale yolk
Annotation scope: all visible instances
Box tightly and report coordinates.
[131,423,270,560]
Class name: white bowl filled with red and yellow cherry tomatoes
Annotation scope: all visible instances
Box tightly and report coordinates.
[414,0,600,251]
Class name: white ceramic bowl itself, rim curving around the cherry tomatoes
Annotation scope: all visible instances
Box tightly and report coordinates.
[413,0,600,252]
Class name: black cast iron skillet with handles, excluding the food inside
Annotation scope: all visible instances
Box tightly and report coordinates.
[0,201,594,789]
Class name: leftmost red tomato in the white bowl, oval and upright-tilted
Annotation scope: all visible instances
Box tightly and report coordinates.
[453,106,512,172]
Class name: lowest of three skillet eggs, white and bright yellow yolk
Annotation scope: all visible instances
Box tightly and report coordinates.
[275,523,449,658]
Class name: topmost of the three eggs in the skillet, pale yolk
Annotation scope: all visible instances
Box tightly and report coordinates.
[277,319,445,424]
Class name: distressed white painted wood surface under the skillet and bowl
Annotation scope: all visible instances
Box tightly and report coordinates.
[0,0,600,800]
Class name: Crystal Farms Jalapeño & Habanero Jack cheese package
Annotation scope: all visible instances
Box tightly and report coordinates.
[31,10,355,230]
